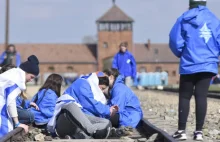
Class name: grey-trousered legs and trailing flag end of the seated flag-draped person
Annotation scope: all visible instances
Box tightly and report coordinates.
[47,94,111,139]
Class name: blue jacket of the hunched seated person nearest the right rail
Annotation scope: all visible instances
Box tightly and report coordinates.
[108,75,143,128]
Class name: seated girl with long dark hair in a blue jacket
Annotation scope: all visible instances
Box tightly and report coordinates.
[16,74,63,127]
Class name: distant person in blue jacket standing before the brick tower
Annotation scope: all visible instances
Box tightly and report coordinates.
[112,42,137,87]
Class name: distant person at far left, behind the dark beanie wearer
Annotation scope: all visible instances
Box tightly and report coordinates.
[0,44,21,67]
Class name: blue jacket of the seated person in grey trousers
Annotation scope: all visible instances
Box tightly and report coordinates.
[64,78,110,118]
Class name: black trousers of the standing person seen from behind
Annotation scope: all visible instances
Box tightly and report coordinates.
[179,72,215,131]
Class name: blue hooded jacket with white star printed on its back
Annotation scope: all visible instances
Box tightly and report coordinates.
[169,6,220,74]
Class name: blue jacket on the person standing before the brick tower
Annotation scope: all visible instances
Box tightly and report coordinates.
[112,51,136,79]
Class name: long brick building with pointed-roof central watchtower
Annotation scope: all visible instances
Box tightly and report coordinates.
[0,4,179,84]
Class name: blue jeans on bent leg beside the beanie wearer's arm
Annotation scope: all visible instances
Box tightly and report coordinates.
[17,107,34,124]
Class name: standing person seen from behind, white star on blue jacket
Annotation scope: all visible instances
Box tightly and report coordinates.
[169,0,220,140]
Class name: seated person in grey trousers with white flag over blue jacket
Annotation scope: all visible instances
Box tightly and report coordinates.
[48,72,116,138]
